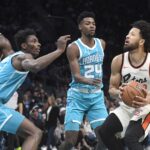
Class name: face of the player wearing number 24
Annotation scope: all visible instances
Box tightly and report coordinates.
[79,17,96,37]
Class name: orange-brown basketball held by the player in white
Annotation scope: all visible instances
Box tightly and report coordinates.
[121,81,146,107]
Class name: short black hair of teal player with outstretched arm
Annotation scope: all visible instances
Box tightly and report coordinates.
[14,28,36,49]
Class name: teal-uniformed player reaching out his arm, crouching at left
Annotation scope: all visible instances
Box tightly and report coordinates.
[0,29,70,150]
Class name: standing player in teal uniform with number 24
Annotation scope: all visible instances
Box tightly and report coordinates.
[60,11,107,150]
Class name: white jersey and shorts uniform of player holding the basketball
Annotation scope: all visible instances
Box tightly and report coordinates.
[111,52,150,141]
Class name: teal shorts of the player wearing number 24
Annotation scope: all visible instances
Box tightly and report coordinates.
[65,88,108,131]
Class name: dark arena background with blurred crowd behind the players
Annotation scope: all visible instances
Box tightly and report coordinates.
[0,0,150,150]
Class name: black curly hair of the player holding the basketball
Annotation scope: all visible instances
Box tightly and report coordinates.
[131,20,150,52]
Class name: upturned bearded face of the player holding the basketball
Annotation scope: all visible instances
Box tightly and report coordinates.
[124,28,142,51]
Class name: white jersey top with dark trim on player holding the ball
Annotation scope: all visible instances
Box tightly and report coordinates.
[121,52,150,91]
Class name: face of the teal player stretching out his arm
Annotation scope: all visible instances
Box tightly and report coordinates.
[25,35,41,57]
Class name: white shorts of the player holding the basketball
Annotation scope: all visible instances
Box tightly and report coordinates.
[110,102,150,141]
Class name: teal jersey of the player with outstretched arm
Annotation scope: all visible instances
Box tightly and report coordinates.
[0,51,28,103]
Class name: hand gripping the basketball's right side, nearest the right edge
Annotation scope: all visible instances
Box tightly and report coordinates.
[132,88,150,108]
